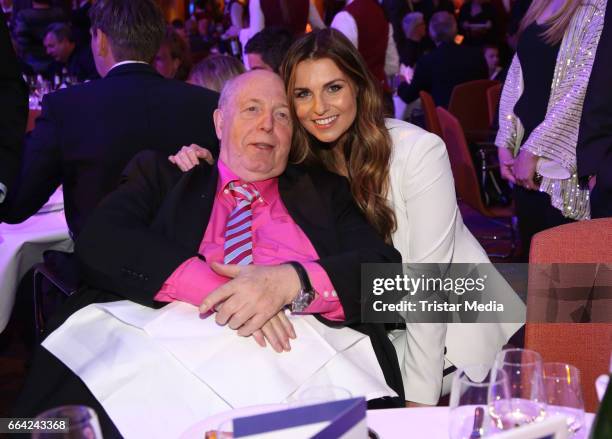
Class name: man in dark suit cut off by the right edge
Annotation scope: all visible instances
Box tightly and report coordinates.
[576,0,612,218]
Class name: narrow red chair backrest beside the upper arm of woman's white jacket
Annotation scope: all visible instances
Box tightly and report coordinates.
[436,107,486,214]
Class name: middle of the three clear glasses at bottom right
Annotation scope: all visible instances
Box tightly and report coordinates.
[489,349,546,430]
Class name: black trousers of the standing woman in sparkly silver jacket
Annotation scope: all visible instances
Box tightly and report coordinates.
[514,185,574,261]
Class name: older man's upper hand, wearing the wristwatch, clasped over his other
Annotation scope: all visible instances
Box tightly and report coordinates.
[200,262,301,337]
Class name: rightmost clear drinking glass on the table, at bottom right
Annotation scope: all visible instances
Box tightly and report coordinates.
[542,363,584,435]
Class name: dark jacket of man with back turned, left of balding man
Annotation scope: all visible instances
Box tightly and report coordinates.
[0,63,218,234]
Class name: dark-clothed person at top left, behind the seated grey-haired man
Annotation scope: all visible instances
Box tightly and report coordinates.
[13,0,68,73]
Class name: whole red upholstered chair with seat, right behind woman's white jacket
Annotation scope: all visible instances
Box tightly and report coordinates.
[436,107,516,257]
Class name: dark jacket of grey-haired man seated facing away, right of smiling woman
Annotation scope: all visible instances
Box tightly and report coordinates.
[397,43,489,108]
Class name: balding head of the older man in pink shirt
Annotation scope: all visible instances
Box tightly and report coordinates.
[214,70,292,181]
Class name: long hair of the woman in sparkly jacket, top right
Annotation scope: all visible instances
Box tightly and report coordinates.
[519,0,582,46]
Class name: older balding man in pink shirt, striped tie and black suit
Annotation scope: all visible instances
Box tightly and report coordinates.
[11,70,402,432]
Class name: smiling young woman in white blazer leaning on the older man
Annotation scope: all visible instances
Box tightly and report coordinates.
[172,29,520,405]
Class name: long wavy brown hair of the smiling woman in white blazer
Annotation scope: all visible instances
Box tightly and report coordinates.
[281,29,396,242]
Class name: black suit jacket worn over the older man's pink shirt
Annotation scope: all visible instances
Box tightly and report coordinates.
[76,151,403,401]
